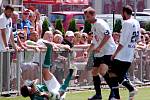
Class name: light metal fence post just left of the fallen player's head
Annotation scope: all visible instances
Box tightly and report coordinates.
[16,52,21,95]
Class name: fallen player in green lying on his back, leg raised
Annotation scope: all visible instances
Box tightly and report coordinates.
[21,42,73,100]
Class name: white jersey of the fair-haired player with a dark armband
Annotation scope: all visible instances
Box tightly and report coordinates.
[91,19,116,57]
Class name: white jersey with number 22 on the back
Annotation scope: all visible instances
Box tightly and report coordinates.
[115,18,141,62]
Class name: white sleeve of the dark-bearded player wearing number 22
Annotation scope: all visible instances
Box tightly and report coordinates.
[119,23,130,45]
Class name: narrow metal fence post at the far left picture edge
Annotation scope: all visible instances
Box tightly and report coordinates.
[0,52,3,95]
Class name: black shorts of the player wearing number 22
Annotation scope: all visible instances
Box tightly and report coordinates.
[111,59,131,77]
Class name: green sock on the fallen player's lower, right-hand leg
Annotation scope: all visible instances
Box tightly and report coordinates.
[60,69,73,91]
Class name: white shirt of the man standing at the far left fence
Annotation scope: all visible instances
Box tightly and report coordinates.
[0,13,12,50]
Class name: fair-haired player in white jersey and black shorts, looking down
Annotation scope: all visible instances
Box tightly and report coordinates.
[84,7,119,100]
